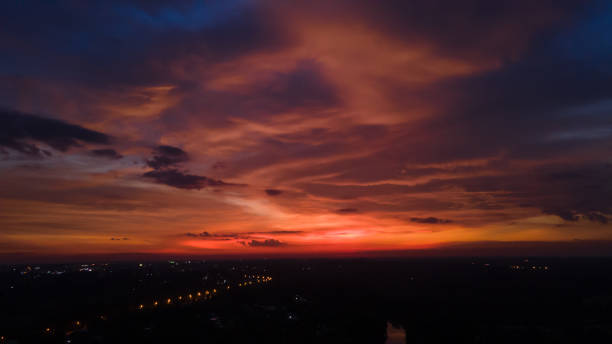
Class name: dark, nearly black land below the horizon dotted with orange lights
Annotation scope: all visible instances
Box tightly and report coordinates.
[0,258,612,344]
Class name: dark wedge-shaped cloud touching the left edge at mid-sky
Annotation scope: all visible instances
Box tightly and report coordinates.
[0,110,110,156]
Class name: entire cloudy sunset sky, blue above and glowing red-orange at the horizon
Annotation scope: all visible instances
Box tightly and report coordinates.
[0,0,612,258]
